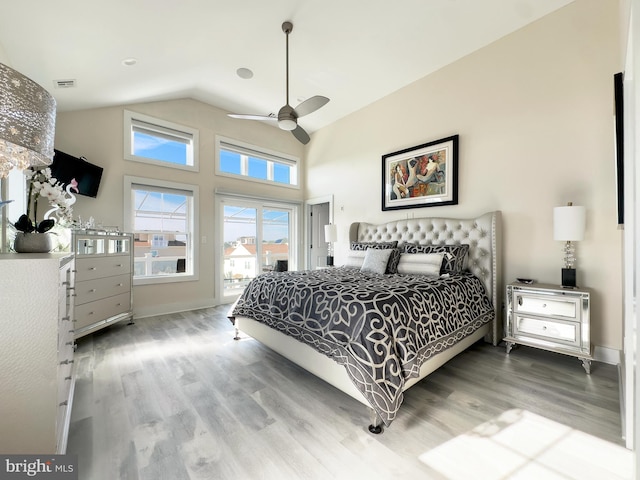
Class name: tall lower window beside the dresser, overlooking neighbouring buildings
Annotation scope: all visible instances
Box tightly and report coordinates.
[124,176,198,285]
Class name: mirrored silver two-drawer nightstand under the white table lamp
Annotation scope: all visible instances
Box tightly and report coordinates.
[504,283,593,373]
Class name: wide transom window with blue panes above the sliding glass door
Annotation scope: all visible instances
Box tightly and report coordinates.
[216,137,299,188]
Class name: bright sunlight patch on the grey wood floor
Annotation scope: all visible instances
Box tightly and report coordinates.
[419,409,633,480]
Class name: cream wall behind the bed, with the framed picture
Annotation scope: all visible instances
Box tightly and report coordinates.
[306,0,622,349]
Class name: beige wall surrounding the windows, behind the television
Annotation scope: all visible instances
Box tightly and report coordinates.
[55,100,304,316]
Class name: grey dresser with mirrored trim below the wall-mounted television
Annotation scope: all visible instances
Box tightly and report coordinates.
[72,230,133,338]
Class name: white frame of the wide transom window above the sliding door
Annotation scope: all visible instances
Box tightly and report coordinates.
[215,135,300,190]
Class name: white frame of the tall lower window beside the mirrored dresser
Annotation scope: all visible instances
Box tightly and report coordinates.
[124,175,200,285]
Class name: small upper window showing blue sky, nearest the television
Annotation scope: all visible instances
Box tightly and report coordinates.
[124,110,198,172]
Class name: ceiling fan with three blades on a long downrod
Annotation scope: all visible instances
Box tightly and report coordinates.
[227,22,329,145]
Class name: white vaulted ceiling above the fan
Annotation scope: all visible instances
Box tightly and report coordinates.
[0,0,574,132]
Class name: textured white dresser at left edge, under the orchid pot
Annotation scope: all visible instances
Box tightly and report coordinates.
[0,253,75,454]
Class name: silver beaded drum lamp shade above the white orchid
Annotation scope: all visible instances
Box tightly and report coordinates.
[0,63,56,178]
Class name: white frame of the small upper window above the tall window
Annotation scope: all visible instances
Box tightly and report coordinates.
[124,110,200,172]
